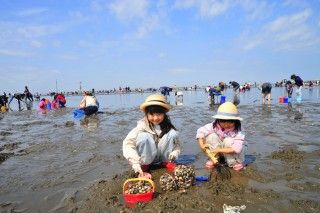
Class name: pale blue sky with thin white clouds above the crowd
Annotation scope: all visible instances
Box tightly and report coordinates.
[0,0,320,93]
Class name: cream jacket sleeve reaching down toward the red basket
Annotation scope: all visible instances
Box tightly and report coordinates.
[122,127,140,164]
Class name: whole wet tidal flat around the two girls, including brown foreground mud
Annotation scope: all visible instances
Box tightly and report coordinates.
[0,88,320,212]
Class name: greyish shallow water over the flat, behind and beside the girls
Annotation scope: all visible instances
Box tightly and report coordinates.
[0,87,320,212]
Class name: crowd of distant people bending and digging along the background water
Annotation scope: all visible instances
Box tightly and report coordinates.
[0,74,304,115]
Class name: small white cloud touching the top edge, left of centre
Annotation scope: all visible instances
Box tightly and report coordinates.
[109,0,148,21]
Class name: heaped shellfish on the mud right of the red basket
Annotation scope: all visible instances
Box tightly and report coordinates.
[160,165,195,191]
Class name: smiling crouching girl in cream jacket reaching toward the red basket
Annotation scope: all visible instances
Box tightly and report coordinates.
[123,94,180,178]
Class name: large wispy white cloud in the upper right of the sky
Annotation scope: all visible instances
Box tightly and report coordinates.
[240,9,320,50]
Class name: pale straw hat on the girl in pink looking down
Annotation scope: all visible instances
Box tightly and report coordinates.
[212,102,242,121]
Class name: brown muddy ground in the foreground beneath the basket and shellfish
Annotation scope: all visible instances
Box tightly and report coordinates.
[57,147,320,212]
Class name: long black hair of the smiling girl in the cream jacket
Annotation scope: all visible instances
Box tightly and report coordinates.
[145,105,177,138]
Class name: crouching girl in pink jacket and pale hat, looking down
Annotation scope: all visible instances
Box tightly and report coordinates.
[196,102,247,171]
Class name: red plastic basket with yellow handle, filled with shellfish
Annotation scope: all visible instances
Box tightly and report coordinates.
[123,178,155,203]
